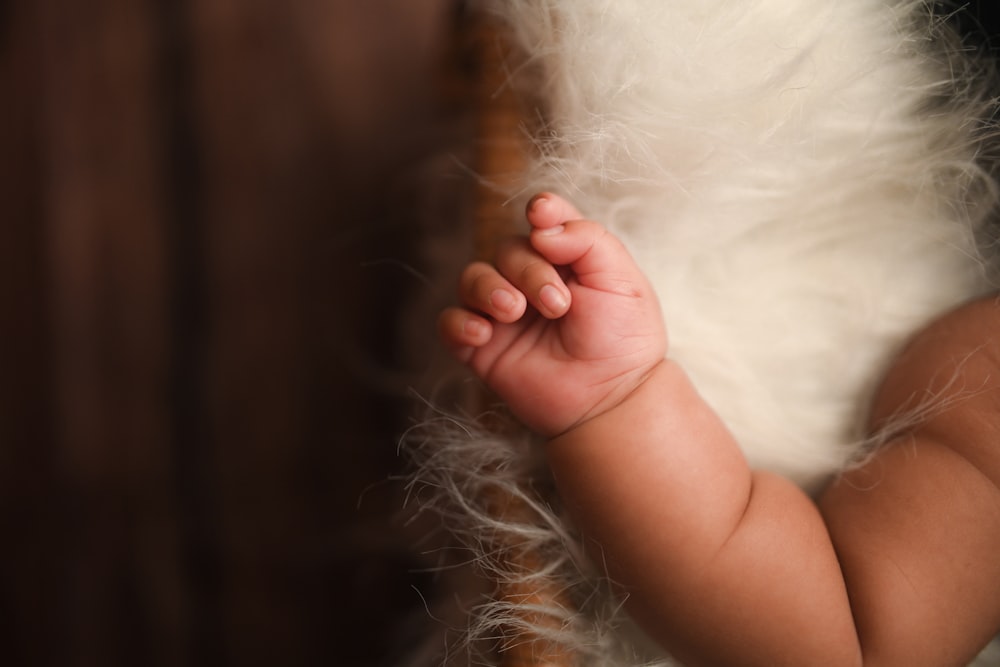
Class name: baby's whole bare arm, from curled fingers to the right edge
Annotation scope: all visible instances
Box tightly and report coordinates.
[440,194,1000,667]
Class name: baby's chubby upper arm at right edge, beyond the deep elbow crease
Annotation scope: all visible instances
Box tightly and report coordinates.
[820,298,1000,665]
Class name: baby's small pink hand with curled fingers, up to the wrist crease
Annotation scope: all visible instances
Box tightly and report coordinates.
[440,194,667,436]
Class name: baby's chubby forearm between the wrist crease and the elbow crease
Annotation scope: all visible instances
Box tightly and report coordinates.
[549,361,859,664]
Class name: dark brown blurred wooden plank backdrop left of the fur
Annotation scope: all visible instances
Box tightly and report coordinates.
[0,0,480,666]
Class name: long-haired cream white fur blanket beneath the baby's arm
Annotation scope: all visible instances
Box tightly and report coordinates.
[405,0,997,665]
